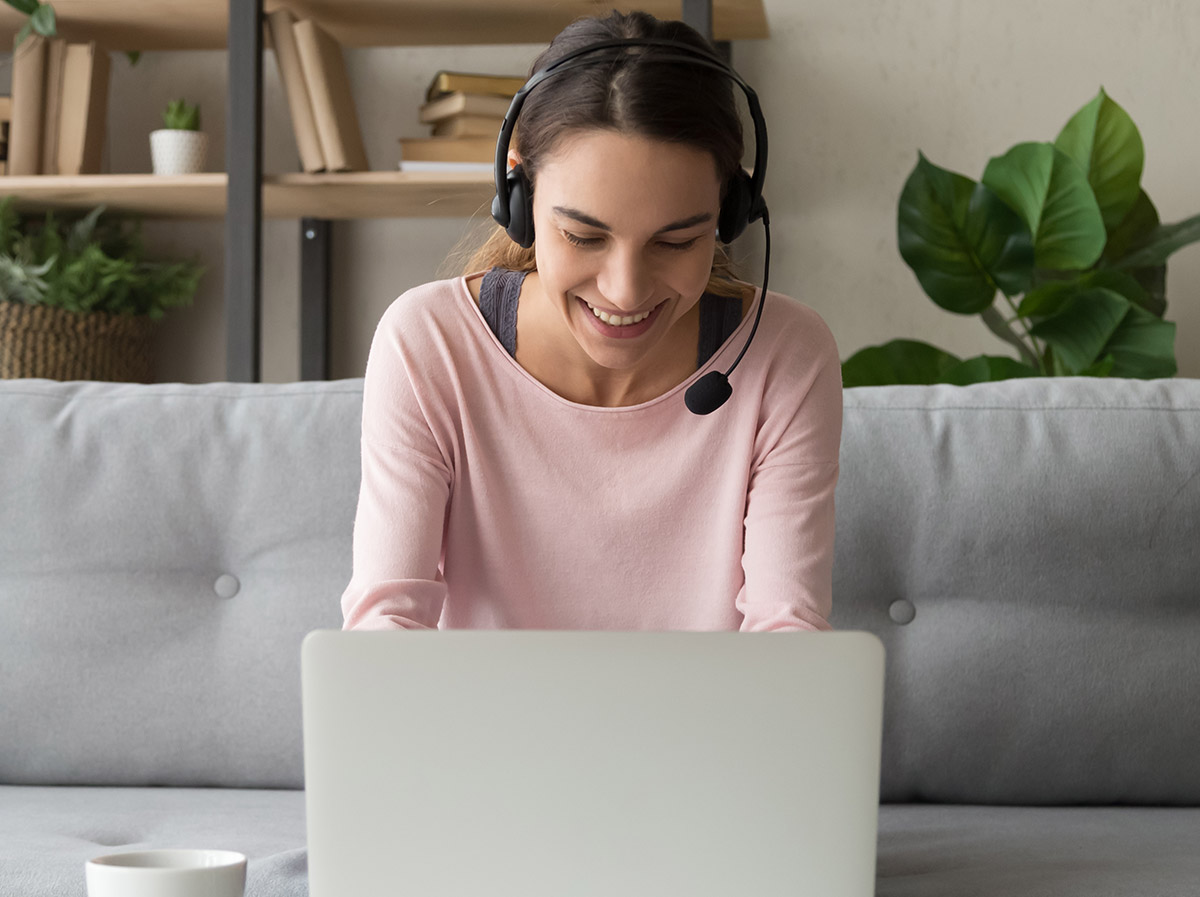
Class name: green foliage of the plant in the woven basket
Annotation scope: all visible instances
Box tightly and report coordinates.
[0,197,204,320]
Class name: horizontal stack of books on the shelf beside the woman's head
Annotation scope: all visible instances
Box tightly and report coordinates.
[400,72,524,171]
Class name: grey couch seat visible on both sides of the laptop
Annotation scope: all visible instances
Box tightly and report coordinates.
[0,787,1200,897]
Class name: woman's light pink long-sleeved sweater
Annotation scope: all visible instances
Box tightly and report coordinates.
[342,277,842,631]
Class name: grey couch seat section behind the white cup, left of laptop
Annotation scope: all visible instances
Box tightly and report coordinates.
[0,785,308,897]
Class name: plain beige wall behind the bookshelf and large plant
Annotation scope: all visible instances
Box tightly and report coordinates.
[16,0,1200,381]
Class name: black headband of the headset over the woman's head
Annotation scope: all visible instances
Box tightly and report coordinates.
[493,37,767,225]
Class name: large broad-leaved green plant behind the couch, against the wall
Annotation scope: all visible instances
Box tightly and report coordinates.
[842,88,1200,386]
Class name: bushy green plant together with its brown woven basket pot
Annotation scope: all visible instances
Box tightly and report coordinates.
[0,197,203,383]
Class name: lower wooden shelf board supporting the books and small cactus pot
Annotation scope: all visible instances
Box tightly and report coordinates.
[0,171,494,219]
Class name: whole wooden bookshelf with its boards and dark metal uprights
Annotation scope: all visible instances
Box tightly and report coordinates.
[0,0,768,381]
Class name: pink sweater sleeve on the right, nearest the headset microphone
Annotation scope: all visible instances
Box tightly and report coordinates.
[737,313,842,632]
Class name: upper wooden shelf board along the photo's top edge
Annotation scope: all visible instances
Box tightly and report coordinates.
[0,0,768,50]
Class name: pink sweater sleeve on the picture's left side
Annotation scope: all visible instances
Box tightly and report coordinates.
[341,296,451,630]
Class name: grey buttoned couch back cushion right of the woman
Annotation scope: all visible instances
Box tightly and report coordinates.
[832,378,1200,805]
